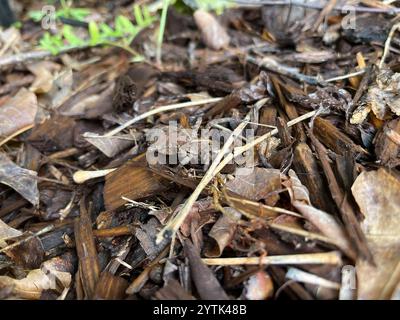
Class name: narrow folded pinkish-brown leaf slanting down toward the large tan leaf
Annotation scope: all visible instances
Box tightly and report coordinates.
[284,170,354,257]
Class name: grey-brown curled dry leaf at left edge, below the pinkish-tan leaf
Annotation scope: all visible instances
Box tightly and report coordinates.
[0,153,39,206]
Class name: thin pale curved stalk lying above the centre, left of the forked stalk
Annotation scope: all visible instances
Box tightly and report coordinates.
[84,98,223,138]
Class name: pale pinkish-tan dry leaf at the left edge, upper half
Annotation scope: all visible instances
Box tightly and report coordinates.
[0,88,38,137]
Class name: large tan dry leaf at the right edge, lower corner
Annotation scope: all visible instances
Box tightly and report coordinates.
[351,169,400,299]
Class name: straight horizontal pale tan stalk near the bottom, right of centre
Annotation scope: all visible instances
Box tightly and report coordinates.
[202,251,342,266]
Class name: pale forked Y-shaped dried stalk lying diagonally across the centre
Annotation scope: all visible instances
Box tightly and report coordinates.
[156,107,317,243]
